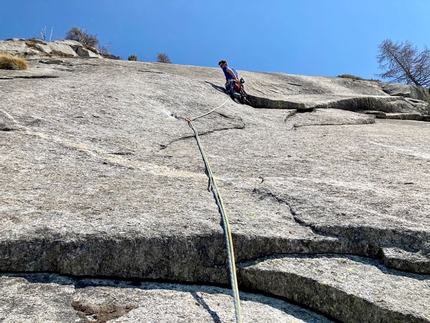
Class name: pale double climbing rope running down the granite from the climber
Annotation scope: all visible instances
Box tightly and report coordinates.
[185,99,242,323]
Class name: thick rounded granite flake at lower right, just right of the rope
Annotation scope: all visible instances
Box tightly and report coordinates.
[240,256,430,323]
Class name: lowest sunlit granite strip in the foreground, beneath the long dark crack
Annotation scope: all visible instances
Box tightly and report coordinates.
[0,274,331,323]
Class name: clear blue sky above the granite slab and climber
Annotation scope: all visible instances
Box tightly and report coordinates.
[0,0,430,78]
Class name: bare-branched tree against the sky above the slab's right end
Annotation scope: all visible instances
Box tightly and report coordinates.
[377,39,430,86]
